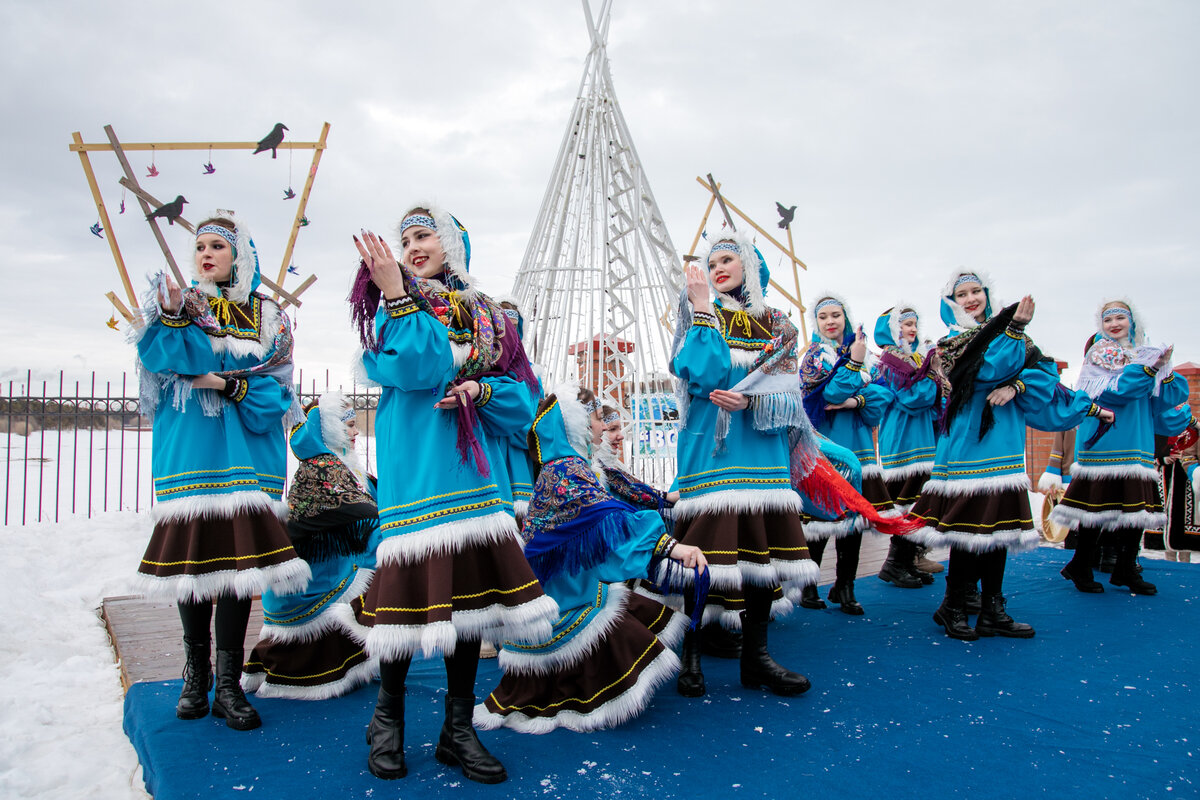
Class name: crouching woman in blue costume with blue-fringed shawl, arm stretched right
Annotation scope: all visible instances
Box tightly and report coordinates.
[475,385,706,733]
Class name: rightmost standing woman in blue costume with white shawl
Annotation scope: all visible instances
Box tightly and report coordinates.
[1050,299,1196,595]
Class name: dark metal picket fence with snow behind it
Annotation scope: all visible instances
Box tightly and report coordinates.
[0,371,379,525]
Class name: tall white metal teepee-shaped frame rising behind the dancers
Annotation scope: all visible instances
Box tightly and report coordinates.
[514,0,684,480]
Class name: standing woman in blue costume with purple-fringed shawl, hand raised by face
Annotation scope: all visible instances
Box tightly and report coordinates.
[350,204,558,783]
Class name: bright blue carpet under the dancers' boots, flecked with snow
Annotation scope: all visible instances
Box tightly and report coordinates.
[125,549,1200,800]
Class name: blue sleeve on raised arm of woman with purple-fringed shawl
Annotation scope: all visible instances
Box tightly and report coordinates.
[362,297,454,392]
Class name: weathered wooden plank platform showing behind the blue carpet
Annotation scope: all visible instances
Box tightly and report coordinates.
[100,535,949,690]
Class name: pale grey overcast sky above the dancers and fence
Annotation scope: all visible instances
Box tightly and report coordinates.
[0,0,1200,393]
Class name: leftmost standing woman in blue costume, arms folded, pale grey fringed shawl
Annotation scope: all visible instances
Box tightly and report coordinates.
[136,215,308,730]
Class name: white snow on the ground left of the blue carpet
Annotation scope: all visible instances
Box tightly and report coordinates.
[0,512,152,800]
